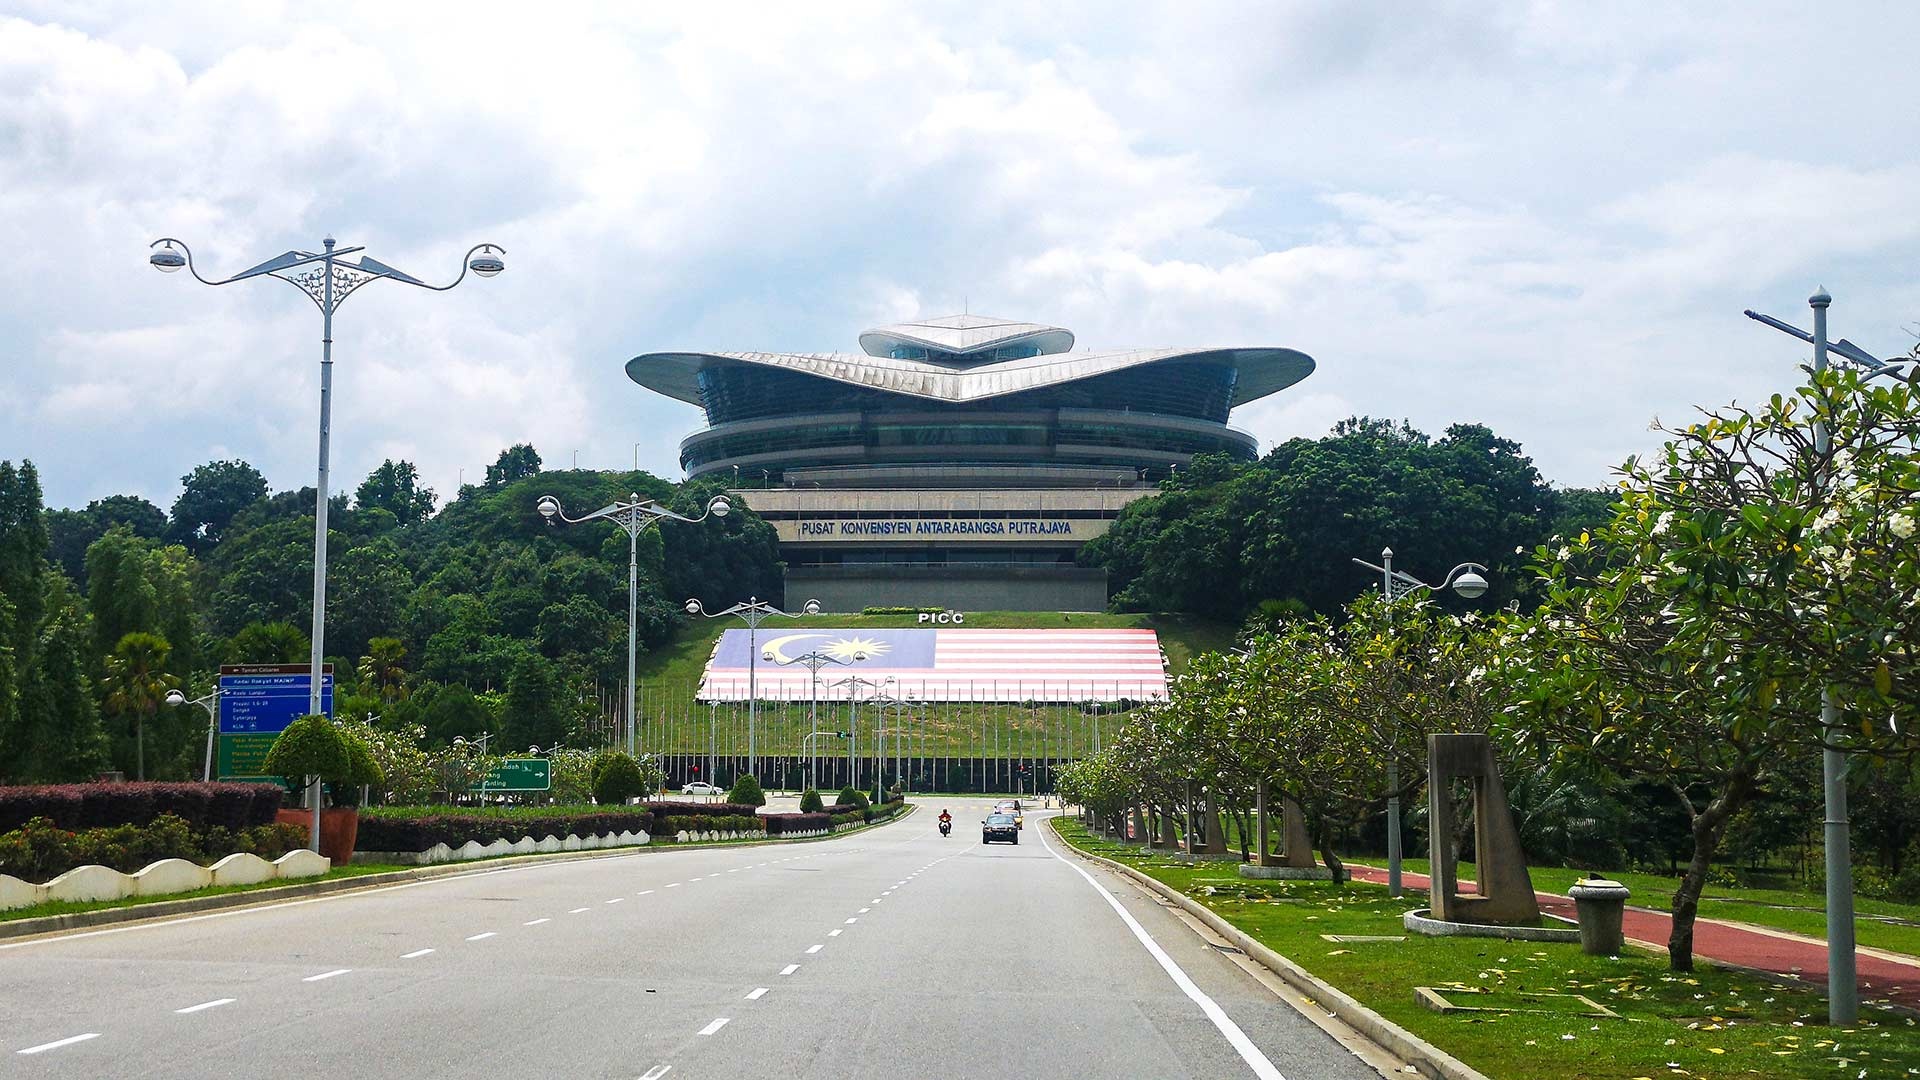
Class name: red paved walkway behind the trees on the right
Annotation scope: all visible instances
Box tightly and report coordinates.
[1346,863,1920,1009]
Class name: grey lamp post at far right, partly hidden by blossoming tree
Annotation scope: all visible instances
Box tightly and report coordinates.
[1745,286,1910,1024]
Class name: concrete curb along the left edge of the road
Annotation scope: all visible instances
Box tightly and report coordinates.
[0,803,918,942]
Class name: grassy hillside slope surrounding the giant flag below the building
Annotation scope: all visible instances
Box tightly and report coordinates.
[622,611,1233,759]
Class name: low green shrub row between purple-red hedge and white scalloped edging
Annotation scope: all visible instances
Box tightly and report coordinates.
[0,810,307,882]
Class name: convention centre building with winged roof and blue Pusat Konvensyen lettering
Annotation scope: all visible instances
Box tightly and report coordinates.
[626,315,1313,611]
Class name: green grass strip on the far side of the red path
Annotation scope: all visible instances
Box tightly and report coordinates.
[1354,855,1920,957]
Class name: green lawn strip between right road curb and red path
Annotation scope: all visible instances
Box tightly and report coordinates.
[1056,819,1920,1080]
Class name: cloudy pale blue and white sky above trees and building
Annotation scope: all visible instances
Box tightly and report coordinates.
[0,0,1920,505]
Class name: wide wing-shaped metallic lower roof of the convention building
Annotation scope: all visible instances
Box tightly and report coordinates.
[626,343,1313,405]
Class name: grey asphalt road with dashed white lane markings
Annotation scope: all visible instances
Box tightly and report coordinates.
[0,799,1379,1080]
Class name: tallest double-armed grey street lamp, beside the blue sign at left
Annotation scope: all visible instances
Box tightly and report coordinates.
[146,236,507,851]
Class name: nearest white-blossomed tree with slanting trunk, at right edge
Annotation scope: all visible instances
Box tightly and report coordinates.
[1500,371,1920,970]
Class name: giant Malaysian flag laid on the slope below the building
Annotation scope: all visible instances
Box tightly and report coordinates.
[699,628,1167,701]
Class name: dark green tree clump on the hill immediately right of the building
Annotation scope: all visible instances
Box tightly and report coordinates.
[1081,419,1607,621]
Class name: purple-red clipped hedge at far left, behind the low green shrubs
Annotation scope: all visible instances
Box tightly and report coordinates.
[0,782,284,832]
